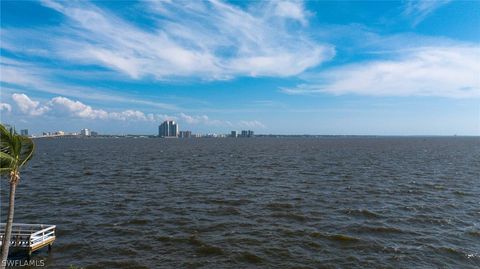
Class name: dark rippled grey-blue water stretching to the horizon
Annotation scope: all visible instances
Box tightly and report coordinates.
[1,137,480,268]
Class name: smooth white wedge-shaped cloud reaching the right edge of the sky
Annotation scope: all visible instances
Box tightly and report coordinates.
[283,45,480,98]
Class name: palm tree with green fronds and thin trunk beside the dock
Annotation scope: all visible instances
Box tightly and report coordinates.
[0,124,35,269]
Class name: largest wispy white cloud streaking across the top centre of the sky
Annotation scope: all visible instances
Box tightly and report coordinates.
[34,0,335,80]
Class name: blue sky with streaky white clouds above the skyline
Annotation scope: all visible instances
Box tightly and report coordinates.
[0,0,480,135]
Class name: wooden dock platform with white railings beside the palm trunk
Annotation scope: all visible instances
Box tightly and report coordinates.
[0,223,56,256]
